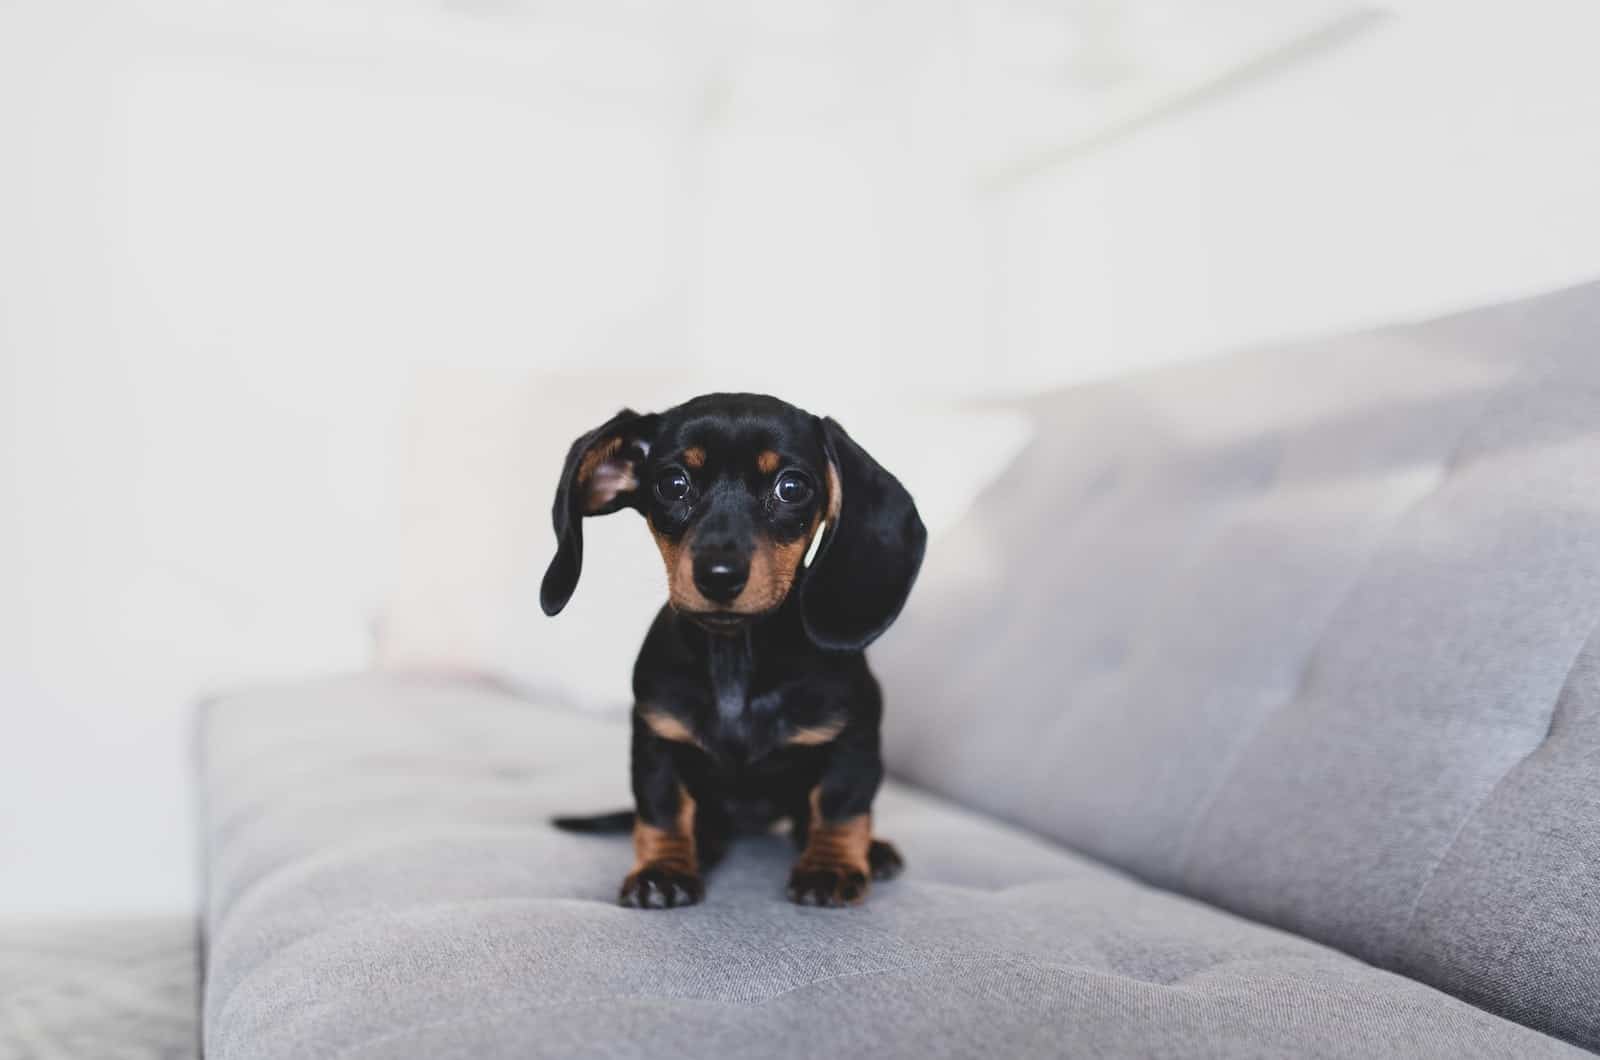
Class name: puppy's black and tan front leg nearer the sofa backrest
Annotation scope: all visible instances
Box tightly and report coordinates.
[789,733,899,906]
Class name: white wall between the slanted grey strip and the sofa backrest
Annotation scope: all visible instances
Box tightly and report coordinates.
[987,0,1600,386]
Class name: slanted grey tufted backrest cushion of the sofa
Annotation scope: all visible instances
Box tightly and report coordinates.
[875,278,1600,1047]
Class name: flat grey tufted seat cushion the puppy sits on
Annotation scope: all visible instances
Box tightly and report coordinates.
[202,677,1579,1060]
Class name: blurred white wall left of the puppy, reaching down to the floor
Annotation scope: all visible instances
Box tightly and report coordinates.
[0,0,677,911]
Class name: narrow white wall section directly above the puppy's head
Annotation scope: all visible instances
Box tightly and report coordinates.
[688,0,995,400]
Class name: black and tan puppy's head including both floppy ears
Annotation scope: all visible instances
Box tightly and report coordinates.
[539,394,928,650]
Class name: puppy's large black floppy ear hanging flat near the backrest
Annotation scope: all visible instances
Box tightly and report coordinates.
[800,418,928,652]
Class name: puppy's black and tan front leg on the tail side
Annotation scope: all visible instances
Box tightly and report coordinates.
[618,714,706,909]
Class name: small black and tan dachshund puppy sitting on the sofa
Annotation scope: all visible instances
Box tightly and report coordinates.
[541,394,928,908]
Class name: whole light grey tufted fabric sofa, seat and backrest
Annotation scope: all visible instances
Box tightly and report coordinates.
[202,287,1600,1060]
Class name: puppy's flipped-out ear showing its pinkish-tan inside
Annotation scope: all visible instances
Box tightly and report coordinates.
[539,408,658,615]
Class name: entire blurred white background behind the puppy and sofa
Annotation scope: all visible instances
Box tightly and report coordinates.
[0,0,1600,914]
